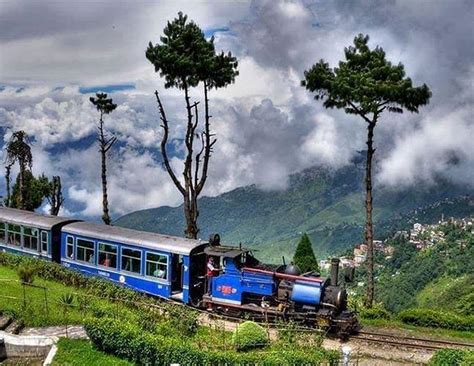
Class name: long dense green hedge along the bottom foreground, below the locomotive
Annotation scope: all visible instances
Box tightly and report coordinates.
[85,318,339,366]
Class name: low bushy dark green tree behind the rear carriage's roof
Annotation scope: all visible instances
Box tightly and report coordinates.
[10,170,51,211]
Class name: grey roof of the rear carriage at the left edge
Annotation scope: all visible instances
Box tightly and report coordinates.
[0,207,77,230]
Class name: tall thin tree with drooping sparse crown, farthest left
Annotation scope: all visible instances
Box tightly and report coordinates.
[5,131,33,209]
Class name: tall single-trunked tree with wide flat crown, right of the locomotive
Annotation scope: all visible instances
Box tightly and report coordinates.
[302,34,431,307]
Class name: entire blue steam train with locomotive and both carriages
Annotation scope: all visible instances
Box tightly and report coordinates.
[0,207,359,335]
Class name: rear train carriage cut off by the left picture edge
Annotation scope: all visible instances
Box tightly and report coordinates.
[0,207,78,263]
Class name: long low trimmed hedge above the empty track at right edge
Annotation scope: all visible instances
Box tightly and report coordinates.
[399,309,474,331]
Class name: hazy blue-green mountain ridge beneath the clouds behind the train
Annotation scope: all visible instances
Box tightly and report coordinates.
[115,163,474,262]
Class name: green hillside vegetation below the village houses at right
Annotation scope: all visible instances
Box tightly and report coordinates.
[377,225,474,316]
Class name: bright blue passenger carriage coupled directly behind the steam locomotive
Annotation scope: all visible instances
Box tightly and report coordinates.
[61,222,207,303]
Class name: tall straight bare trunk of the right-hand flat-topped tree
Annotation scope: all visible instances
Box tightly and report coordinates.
[365,119,376,308]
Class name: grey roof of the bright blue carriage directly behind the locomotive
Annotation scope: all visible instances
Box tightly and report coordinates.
[63,222,207,255]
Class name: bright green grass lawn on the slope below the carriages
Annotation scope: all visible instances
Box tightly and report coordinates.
[0,266,132,327]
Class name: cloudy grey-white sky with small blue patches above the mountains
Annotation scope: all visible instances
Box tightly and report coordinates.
[0,0,474,218]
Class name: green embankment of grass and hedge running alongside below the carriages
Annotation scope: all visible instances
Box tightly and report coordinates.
[0,253,197,334]
